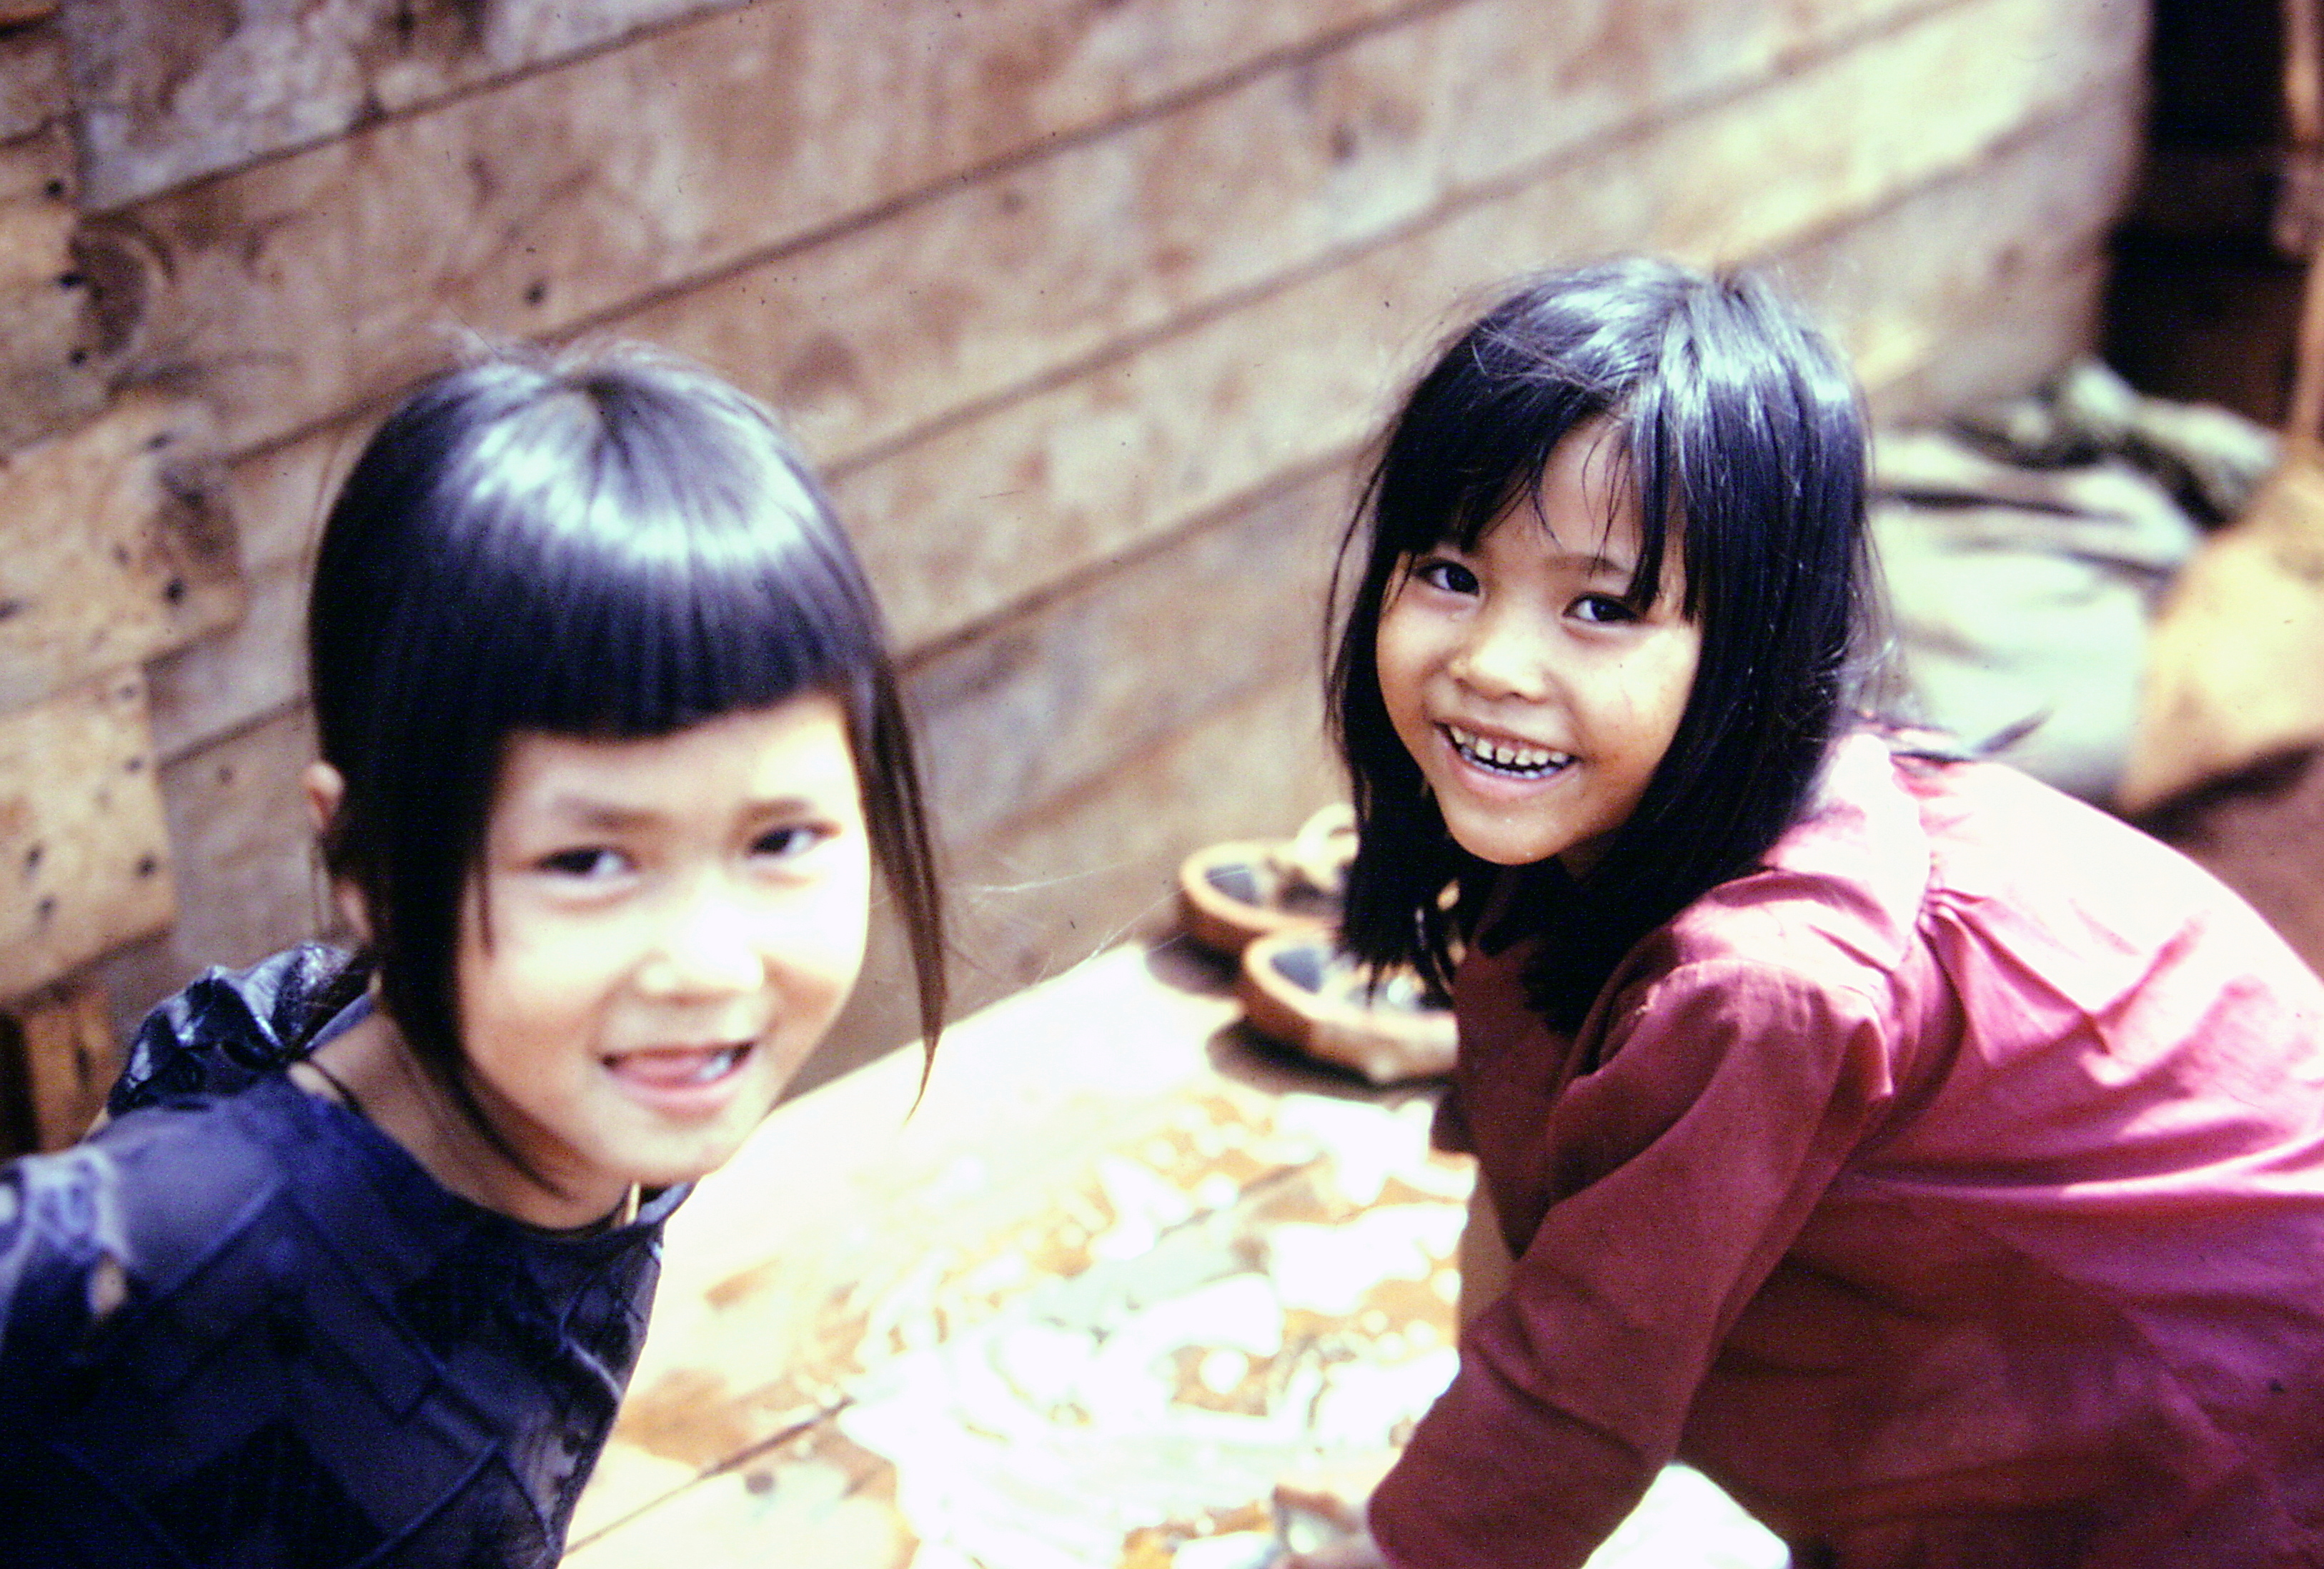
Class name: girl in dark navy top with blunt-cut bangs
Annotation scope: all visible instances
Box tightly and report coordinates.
[0,351,943,1569]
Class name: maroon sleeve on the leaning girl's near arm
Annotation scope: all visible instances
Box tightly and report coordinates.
[1371,960,1892,1569]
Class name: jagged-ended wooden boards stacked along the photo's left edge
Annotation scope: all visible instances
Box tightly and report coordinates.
[0,0,242,1146]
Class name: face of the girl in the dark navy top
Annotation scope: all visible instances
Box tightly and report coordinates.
[455,693,872,1222]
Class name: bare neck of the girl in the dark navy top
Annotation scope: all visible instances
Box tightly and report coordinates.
[293,1006,635,1232]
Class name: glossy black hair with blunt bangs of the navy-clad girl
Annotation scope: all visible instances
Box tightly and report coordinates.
[307,347,946,1153]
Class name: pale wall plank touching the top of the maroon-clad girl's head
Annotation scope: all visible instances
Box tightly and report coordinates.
[834,0,2138,646]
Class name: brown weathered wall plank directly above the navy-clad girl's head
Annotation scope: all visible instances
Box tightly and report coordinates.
[113,0,1431,451]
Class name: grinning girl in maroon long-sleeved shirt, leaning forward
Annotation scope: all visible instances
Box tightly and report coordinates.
[1309,262,2324,1569]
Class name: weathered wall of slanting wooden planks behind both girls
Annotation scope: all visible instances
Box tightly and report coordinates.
[0,0,2145,1129]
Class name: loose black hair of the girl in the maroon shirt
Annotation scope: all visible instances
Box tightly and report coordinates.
[1329,260,1869,1030]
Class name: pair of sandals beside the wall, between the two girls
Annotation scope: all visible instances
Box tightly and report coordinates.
[1178,806,1455,1083]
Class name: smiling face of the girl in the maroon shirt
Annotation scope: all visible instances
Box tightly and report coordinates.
[1376,421,1704,874]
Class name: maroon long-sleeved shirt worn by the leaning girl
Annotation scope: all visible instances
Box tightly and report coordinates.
[1371,737,2324,1569]
